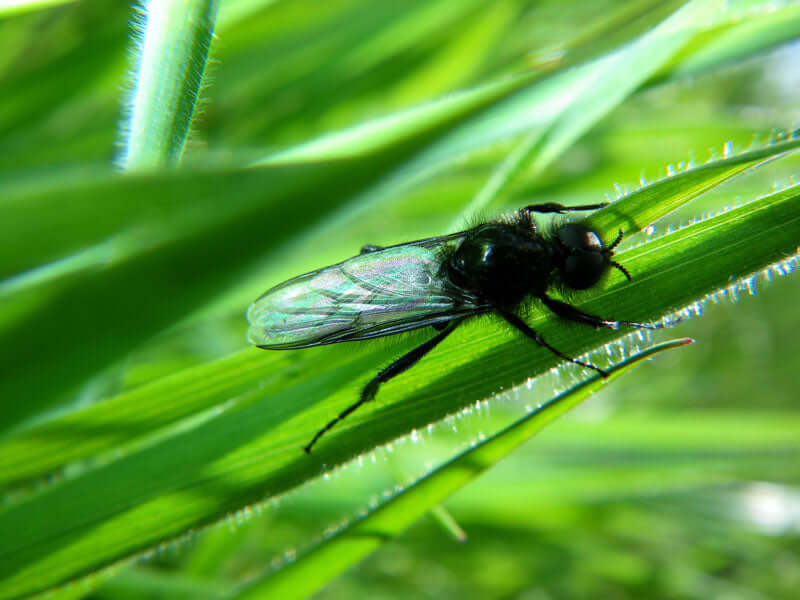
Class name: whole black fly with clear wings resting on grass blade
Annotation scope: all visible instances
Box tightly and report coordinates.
[247,203,654,452]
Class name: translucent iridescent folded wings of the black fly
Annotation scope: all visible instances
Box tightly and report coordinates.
[247,234,488,349]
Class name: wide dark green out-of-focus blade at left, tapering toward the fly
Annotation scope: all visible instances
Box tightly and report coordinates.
[0,161,392,429]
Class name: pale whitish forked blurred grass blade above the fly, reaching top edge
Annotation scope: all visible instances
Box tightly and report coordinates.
[350,0,717,229]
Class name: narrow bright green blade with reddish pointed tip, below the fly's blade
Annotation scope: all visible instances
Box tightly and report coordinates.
[236,339,691,600]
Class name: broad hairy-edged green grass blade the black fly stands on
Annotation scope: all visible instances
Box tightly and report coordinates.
[0,179,800,598]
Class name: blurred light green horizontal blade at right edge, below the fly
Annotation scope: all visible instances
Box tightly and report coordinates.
[446,412,800,506]
